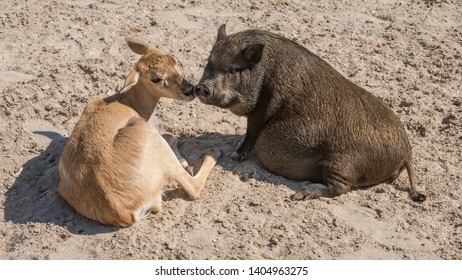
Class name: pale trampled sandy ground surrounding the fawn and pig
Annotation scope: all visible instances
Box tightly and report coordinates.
[0,0,462,259]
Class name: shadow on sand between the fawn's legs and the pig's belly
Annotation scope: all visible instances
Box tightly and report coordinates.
[173,132,408,200]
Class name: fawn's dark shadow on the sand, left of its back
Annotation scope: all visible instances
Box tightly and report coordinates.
[4,131,119,235]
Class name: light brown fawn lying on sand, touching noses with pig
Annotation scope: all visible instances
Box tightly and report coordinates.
[58,38,221,226]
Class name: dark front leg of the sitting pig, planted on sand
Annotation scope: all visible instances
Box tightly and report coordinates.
[231,113,263,162]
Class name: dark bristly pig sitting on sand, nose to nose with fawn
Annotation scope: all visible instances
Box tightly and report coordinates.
[195,25,426,202]
